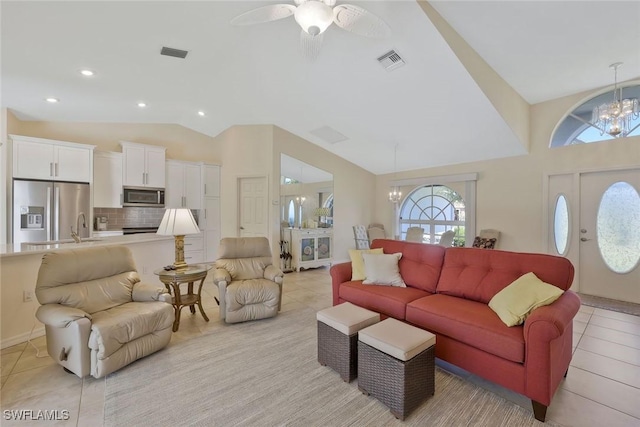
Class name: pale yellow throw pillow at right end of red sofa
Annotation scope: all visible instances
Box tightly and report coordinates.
[489,273,564,326]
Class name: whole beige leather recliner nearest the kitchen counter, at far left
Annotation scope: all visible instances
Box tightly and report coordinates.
[36,246,174,378]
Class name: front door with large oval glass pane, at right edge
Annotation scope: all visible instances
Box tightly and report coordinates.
[579,169,640,303]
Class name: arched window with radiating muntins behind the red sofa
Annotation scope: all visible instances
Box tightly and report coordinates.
[400,185,465,246]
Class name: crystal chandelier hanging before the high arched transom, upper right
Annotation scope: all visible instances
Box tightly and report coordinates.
[591,62,639,138]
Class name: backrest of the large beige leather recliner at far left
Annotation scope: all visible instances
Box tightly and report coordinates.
[36,246,140,314]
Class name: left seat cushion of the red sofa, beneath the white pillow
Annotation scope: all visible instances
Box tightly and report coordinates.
[339,280,430,320]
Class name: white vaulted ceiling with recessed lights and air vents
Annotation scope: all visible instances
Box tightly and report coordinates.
[0,0,640,174]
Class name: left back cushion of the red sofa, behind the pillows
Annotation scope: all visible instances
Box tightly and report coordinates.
[371,239,445,293]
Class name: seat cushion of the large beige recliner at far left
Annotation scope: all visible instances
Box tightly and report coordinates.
[89,301,173,360]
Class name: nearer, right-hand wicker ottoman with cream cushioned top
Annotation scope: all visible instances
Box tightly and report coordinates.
[358,318,436,420]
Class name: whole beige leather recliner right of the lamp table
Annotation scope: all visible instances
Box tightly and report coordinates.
[213,237,284,323]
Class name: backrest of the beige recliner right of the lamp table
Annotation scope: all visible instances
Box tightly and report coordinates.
[216,237,272,280]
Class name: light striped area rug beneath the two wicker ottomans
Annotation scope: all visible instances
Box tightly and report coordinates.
[104,309,556,427]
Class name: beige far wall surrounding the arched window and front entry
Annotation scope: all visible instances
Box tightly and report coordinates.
[375,85,640,252]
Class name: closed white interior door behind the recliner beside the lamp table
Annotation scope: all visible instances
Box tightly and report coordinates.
[238,177,269,237]
